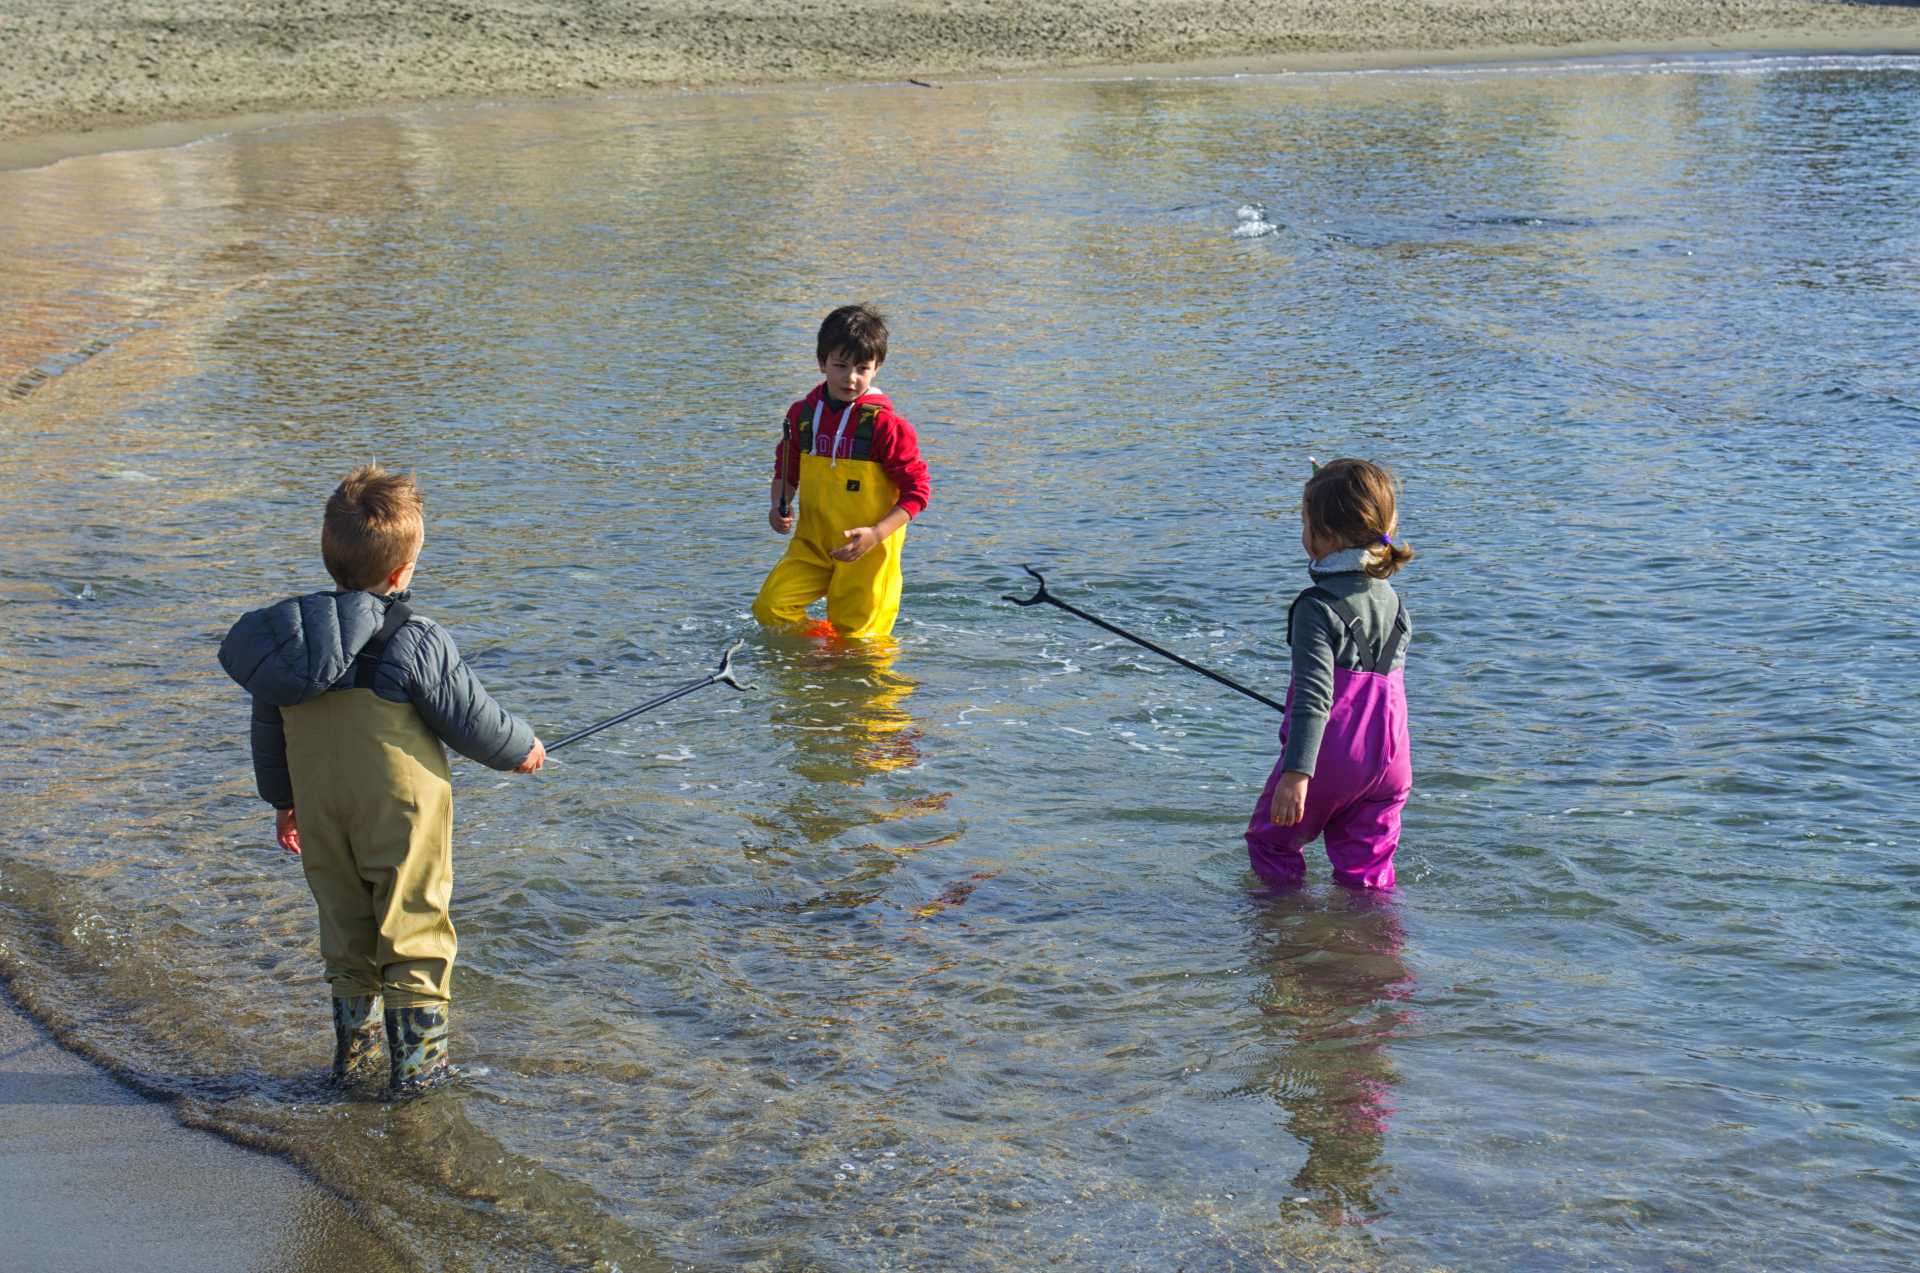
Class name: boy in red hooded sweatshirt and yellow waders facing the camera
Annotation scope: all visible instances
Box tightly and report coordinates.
[753,305,931,637]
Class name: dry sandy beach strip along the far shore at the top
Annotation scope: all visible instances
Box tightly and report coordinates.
[11,0,1920,150]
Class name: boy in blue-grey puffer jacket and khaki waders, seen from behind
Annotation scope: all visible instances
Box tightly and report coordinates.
[221,467,547,1091]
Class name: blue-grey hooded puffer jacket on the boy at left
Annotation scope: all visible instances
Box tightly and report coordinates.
[221,591,534,808]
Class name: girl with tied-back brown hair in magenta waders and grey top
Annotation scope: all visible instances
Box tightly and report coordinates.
[1246,459,1413,889]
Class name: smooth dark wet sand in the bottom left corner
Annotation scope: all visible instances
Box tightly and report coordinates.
[0,991,409,1273]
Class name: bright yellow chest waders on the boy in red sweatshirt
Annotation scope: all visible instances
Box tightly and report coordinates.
[753,403,906,637]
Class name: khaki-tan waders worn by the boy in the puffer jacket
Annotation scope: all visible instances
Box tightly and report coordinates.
[280,606,455,1008]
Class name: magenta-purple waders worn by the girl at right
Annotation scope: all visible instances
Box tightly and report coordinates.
[1246,588,1413,889]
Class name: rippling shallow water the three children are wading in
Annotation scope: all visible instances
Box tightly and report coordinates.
[0,58,1920,1269]
